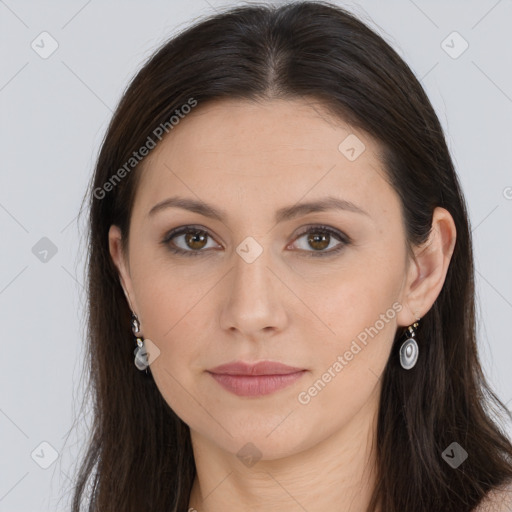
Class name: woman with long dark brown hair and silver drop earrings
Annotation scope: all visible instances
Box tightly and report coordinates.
[73,2,512,512]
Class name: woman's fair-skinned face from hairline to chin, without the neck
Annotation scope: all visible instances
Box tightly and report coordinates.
[110,100,420,459]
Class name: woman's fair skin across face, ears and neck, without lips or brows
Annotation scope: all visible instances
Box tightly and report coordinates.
[109,100,456,512]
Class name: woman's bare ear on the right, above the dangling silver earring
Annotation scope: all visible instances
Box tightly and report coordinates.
[397,207,457,327]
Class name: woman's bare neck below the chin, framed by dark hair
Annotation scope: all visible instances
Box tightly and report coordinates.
[189,393,378,512]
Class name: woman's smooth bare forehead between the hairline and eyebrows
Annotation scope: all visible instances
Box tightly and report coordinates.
[131,100,393,220]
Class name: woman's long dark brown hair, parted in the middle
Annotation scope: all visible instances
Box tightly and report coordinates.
[73,2,512,512]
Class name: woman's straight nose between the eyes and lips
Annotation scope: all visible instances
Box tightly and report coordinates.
[220,242,290,340]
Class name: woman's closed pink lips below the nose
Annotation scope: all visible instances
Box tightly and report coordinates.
[208,361,306,396]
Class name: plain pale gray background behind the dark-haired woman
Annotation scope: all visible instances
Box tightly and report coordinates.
[0,0,512,512]
